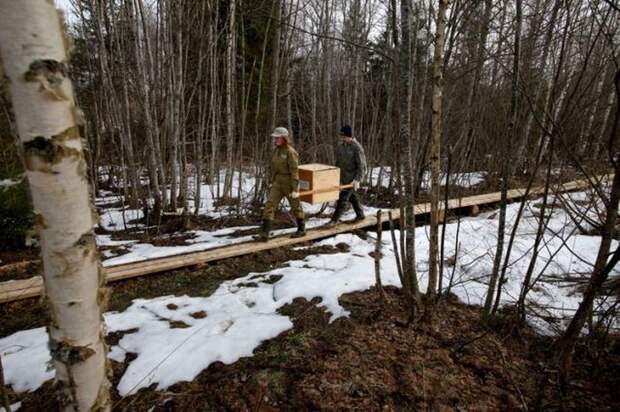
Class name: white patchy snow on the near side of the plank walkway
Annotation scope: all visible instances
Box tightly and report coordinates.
[0,188,620,396]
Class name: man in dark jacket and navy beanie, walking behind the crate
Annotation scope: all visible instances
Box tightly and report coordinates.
[330,125,366,224]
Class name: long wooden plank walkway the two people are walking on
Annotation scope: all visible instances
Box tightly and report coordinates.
[0,176,613,303]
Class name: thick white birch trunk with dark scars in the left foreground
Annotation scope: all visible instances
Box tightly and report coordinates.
[0,0,110,411]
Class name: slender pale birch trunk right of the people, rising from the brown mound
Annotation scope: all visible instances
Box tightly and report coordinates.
[426,0,448,301]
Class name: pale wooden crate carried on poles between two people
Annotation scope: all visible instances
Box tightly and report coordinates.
[299,163,340,204]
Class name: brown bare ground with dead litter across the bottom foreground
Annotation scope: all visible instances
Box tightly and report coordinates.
[7,288,620,411]
